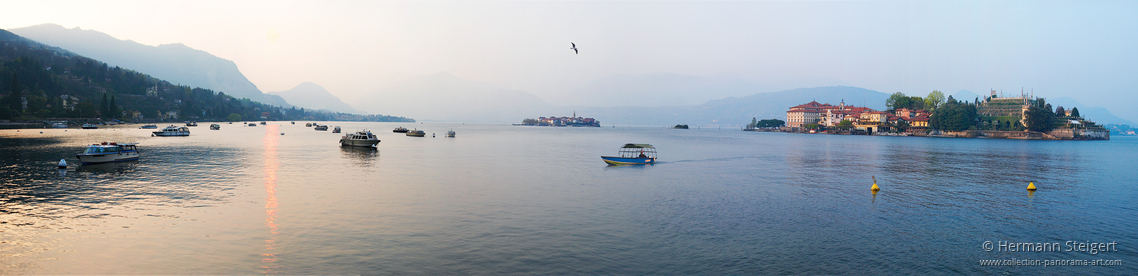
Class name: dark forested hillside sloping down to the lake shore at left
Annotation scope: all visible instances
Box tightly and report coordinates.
[0,30,413,122]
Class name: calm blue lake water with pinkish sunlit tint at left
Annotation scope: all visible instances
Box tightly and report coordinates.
[0,122,1138,275]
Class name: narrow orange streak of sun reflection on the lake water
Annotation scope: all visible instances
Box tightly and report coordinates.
[261,125,280,274]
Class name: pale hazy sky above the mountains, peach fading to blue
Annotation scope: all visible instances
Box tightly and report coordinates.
[0,0,1138,120]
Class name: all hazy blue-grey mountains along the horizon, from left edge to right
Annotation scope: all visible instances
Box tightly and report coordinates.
[11,24,1133,126]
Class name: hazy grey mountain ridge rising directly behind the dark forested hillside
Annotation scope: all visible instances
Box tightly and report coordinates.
[9,24,291,107]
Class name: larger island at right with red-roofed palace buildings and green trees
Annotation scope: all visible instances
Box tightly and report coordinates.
[778,91,1111,140]
